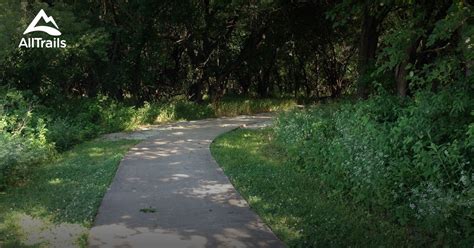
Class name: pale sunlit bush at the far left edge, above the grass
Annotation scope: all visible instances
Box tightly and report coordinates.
[0,90,54,188]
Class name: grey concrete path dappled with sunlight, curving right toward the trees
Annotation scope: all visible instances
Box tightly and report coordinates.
[89,115,284,248]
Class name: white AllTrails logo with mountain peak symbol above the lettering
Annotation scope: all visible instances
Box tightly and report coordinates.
[18,10,66,48]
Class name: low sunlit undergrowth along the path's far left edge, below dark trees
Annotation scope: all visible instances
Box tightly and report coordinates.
[0,87,296,190]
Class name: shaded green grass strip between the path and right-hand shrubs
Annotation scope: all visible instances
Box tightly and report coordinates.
[211,130,409,247]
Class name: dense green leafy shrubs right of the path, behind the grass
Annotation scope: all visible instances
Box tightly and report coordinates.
[275,84,474,246]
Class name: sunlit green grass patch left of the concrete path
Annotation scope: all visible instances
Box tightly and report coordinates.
[0,140,137,247]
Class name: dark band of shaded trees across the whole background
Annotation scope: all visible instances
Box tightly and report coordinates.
[0,0,474,103]
